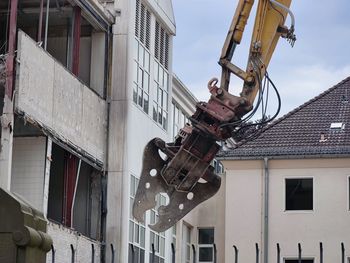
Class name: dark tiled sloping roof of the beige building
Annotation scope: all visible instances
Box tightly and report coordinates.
[218,77,350,159]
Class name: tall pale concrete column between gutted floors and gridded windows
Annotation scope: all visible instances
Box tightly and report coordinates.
[106,0,135,263]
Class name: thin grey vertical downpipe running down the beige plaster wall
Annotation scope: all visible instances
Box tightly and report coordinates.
[263,157,270,263]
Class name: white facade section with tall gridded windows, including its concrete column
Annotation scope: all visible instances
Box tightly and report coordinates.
[106,0,175,262]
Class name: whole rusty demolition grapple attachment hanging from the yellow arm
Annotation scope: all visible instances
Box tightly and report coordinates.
[133,80,252,232]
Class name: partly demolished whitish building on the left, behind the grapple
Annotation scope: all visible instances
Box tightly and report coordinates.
[0,0,224,263]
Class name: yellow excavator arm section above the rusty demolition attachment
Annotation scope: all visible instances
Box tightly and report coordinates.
[219,0,296,106]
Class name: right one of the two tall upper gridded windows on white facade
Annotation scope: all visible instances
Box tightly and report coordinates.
[153,21,170,130]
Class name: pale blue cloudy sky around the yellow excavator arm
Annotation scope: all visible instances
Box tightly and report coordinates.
[173,0,350,116]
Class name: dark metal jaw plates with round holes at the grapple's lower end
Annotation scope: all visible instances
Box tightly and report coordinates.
[133,138,221,232]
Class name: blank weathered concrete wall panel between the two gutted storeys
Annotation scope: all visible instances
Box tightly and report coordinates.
[16,32,107,162]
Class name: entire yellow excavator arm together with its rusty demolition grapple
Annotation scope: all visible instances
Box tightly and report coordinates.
[133,0,296,232]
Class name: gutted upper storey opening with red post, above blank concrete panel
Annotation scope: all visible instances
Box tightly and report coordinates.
[0,1,109,97]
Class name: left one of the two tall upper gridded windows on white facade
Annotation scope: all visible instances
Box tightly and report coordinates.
[133,0,151,113]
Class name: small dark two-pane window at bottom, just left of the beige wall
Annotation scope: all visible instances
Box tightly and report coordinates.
[198,228,214,263]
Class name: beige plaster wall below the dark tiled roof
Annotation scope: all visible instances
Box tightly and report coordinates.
[224,158,350,262]
